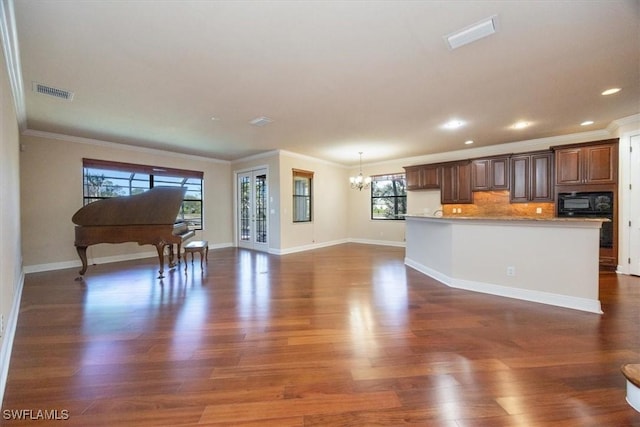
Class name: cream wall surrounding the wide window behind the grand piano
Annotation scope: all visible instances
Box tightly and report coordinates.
[20,131,233,272]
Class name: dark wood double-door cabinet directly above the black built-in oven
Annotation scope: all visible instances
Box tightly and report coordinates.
[554,139,618,186]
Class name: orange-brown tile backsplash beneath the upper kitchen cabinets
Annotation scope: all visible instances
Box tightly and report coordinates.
[442,191,556,218]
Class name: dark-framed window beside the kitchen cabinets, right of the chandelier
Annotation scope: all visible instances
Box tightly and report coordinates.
[371,173,407,219]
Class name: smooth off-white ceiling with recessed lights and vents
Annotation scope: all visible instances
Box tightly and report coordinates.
[8,0,640,165]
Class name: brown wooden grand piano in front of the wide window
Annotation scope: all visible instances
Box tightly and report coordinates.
[71,187,195,279]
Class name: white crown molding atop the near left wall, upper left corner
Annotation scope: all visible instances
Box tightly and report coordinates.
[0,0,27,132]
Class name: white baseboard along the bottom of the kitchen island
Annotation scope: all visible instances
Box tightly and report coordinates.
[404,258,602,314]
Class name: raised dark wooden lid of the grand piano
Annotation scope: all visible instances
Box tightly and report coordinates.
[71,187,187,225]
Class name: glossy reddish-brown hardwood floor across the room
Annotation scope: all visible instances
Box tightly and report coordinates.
[0,244,640,427]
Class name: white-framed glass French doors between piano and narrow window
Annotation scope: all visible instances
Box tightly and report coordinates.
[236,168,269,251]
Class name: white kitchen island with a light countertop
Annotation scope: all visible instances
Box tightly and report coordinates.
[405,215,606,313]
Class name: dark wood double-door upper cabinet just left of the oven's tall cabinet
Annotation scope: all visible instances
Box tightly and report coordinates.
[510,151,554,203]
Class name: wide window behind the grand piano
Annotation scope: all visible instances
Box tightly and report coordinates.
[82,159,204,230]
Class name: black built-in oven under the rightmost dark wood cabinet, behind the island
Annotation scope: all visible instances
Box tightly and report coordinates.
[556,191,614,248]
